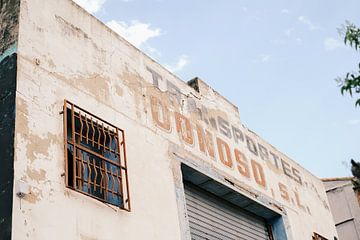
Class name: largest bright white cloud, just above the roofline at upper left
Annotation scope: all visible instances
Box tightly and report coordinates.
[106,20,161,47]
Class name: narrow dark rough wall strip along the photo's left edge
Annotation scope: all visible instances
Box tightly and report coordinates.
[0,0,19,240]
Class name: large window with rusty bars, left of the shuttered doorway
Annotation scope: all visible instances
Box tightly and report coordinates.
[63,100,130,211]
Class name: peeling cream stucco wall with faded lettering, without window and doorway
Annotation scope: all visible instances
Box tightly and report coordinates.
[13,0,336,240]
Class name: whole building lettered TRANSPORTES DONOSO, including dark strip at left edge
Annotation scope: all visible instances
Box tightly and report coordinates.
[0,0,337,240]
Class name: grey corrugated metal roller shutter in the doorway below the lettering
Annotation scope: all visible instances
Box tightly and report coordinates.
[185,185,270,240]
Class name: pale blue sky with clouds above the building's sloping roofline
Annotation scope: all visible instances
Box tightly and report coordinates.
[76,0,360,177]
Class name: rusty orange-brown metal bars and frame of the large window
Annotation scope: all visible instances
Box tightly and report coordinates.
[62,99,131,212]
